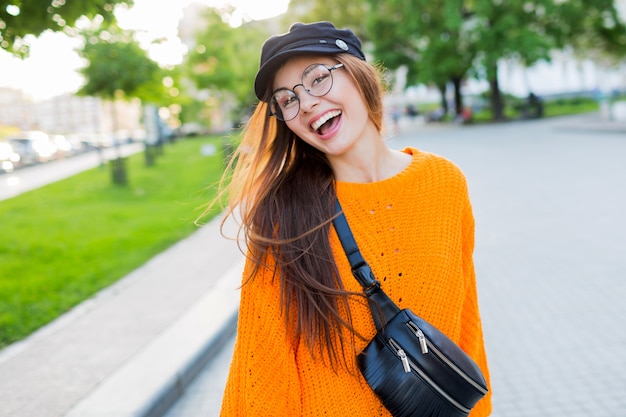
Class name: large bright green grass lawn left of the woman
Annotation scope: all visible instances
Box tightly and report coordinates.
[0,137,229,347]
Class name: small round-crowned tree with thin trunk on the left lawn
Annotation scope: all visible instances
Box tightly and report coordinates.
[78,21,163,184]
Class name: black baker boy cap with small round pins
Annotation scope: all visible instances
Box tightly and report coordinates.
[254,22,365,100]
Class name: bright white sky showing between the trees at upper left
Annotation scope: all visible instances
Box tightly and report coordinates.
[0,0,289,101]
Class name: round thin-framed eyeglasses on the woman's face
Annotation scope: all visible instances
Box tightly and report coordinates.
[270,64,343,122]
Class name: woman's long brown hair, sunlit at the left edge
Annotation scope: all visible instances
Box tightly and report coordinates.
[218,54,383,365]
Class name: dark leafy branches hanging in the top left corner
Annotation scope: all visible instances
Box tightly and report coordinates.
[0,0,134,57]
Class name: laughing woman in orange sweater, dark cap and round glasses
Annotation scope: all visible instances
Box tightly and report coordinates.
[221,22,491,417]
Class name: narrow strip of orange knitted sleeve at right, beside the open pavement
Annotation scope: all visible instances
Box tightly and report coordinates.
[459,201,491,417]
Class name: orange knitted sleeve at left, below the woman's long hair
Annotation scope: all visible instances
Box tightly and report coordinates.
[220,252,301,417]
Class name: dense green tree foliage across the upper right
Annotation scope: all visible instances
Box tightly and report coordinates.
[360,0,626,119]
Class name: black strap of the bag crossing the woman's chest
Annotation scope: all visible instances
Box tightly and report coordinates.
[333,199,400,331]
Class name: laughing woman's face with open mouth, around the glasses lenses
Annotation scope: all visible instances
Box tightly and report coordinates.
[273,56,379,157]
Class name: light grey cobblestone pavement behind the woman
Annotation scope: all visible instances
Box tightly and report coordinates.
[166,118,626,417]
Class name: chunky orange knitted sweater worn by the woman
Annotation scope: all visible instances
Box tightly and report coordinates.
[221,148,491,417]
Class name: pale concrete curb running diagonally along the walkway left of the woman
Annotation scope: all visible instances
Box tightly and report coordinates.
[65,261,243,417]
